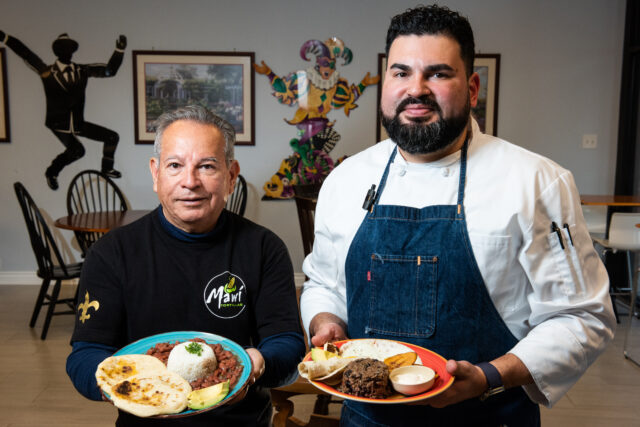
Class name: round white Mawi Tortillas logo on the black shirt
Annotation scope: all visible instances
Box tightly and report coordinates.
[204,271,247,319]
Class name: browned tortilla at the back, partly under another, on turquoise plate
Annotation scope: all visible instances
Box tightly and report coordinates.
[96,354,167,394]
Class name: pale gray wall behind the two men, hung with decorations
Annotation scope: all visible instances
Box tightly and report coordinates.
[0,0,625,282]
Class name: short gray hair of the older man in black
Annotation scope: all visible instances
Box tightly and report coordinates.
[153,105,236,167]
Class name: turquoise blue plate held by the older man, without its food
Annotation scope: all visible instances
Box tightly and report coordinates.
[103,331,251,418]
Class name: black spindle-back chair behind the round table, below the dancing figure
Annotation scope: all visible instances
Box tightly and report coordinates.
[67,170,128,257]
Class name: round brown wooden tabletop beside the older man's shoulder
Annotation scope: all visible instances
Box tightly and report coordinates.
[54,209,151,233]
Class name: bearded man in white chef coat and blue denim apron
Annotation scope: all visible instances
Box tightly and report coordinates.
[301,6,615,426]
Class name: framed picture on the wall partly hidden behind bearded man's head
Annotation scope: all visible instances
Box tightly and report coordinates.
[376,53,500,141]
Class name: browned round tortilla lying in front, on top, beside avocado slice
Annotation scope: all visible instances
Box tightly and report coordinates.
[111,371,191,417]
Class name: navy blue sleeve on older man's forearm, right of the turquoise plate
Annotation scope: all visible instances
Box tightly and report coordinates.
[257,332,305,388]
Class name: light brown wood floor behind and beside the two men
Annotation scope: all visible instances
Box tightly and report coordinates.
[0,285,640,427]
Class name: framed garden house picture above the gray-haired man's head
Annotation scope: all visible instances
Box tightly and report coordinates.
[132,50,255,145]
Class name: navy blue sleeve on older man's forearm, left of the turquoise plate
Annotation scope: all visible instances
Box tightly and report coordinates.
[67,341,117,400]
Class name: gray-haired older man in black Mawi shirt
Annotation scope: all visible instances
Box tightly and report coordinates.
[67,107,305,426]
